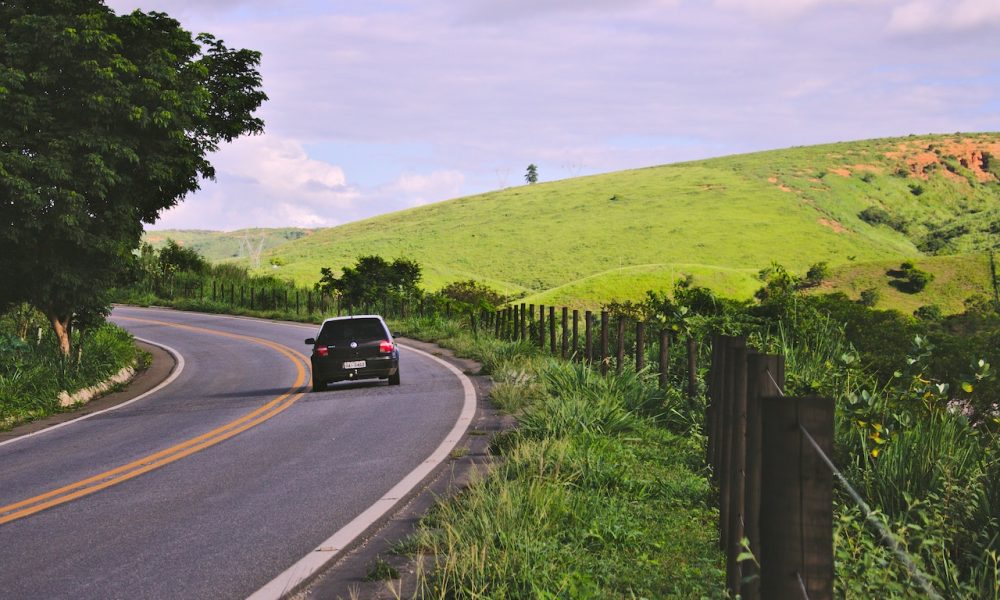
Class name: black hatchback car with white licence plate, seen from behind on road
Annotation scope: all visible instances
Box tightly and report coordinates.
[306,315,399,392]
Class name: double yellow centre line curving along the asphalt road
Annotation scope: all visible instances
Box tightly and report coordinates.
[0,317,307,525]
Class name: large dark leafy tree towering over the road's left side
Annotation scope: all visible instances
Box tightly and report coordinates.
[0,0,267,356]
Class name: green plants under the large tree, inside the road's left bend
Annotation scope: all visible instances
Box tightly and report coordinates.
[0,305,146,431]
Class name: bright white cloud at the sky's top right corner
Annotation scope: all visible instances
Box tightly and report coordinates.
[888,0,1000,34]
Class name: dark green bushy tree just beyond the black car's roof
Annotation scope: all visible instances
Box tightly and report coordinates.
[316,255,421,308]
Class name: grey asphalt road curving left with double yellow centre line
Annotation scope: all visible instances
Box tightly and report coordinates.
[0,308,468,600]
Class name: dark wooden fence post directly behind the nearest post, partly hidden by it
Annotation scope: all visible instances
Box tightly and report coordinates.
[740,353,785,600]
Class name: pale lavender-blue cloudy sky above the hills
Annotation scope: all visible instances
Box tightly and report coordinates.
[106,0,1000,230]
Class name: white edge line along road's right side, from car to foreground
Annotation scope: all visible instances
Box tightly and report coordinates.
[247,344,476,600]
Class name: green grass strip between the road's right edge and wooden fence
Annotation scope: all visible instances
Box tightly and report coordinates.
[394,319,724,598]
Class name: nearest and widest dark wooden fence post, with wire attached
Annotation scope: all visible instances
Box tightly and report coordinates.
[760,396,834,600]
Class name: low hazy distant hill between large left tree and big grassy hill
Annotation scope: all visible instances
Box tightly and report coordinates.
[143,227,313,265]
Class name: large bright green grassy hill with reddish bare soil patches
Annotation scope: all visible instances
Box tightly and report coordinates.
[180,133,1000,314]
